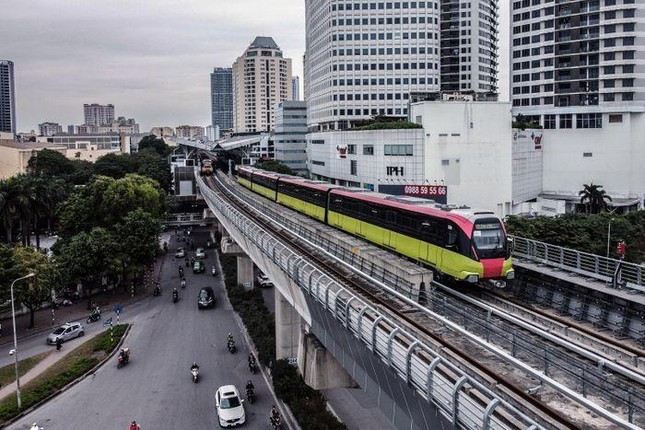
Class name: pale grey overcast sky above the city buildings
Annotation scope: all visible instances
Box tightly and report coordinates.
[0,0,509,131]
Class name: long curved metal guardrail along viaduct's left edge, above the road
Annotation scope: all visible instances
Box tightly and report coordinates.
[196,176,543,429]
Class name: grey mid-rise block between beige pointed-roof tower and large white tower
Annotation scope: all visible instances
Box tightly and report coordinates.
[273,100,307,173]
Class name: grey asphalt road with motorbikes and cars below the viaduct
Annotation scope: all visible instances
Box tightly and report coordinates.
[8,231,274,430]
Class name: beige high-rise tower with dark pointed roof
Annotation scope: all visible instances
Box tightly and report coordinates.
[233,36,291,133]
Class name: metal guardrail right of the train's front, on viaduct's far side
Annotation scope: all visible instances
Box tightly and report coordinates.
[513,236,645,293]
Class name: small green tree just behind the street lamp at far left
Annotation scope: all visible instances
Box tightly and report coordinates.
[15,247,60,328]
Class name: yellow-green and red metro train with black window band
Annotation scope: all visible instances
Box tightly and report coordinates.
[237,166,515,283]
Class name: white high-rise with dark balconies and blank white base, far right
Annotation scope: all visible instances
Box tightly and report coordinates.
[510,0,645,209]
